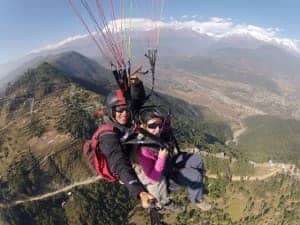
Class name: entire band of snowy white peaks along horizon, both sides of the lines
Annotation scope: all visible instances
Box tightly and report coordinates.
[7,17,300,59]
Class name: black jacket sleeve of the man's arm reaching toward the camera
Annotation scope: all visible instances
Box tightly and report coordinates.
[99,132,145,197]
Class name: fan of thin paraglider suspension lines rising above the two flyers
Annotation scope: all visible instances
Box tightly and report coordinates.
[69,0,164,101]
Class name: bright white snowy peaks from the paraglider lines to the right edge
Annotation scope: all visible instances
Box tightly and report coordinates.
[109,17,300,54]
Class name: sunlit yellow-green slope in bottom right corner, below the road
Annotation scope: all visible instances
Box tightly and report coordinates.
[174,176,300,225]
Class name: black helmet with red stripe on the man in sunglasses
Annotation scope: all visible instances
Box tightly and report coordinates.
[105,89,127,117]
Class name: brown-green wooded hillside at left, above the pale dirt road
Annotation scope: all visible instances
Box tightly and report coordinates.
[0,63,103,201]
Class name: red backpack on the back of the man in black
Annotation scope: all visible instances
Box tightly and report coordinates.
[83,124,119,182]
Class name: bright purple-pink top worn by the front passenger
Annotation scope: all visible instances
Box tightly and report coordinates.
[138,147,167,183]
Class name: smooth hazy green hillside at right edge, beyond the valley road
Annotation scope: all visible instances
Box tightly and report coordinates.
[238,116,300,167]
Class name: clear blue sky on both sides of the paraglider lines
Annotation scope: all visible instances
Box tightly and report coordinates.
[0,0,300,64]
